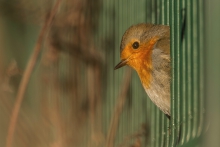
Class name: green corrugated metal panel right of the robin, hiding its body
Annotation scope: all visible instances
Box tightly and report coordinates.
[170,1,204,146]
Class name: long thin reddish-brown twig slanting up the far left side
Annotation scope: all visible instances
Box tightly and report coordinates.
[6,0,62,147]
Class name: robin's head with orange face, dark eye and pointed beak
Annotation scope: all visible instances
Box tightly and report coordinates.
[115,24,169,72]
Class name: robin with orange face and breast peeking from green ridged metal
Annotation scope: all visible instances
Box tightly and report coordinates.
[114,23,171,118]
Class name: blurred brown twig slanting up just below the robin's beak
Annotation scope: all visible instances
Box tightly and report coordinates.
[106,68,131,147]
